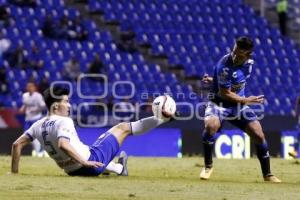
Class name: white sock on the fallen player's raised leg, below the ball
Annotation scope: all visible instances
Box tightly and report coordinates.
[130,116,170,135]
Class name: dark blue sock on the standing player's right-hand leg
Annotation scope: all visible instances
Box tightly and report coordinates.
[255,141,271,177]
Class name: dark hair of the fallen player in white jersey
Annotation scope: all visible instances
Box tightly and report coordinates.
[43,86,70,110]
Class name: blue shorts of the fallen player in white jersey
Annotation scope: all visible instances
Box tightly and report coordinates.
[68,132,120,176]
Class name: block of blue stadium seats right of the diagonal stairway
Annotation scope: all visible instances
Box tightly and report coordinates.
[89,0,300,114]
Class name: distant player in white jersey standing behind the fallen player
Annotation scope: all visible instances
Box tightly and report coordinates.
[20,82,46,157]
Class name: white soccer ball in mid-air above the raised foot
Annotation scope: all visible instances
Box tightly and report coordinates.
[152,95,176,119]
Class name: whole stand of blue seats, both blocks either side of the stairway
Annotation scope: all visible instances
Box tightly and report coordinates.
[0,0,300,115]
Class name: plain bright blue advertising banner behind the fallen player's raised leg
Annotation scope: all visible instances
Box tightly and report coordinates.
[77,128,182,157]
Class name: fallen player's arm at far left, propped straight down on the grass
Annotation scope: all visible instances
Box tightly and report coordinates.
[11,134,31,174]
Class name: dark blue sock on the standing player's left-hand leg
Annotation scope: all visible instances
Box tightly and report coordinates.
[202,130,215,168]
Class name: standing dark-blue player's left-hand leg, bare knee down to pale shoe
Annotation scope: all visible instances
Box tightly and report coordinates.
[200,116,221,180]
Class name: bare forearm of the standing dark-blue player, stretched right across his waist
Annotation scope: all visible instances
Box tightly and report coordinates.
[219,87,264,104]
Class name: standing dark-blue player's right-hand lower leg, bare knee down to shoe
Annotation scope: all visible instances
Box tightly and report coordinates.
[245,120,281,183]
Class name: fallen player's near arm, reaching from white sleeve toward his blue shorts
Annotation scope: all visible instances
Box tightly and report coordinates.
[58,137,104,168]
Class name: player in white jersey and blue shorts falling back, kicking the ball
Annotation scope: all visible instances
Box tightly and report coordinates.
[11,87,170,176]
